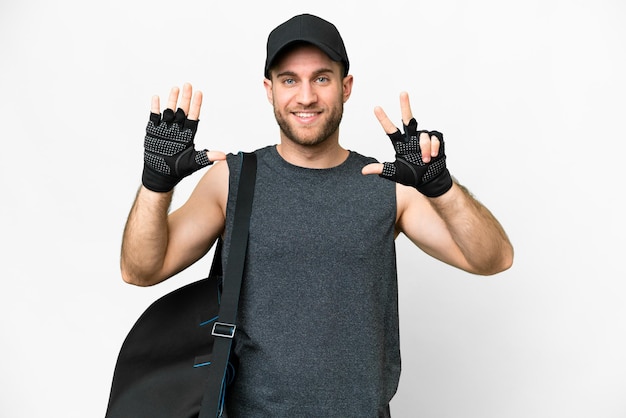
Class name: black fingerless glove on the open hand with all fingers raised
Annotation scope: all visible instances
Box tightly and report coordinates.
[141,109,212,192]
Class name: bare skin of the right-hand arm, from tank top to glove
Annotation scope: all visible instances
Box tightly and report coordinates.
[397,182,513,275]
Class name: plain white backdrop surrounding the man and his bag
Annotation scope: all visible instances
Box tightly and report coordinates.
[0,0,626,418]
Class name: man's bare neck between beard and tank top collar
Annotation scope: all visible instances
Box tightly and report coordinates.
[276,138,350,169]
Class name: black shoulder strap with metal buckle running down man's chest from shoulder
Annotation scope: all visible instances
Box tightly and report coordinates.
[199,153,256,418]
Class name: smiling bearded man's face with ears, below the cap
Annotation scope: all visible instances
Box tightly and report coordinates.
[265,45,352,146]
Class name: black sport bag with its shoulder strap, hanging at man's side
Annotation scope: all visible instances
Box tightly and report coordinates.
[105,153,256,418]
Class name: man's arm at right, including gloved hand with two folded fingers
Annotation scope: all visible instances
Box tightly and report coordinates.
[363,92,513,275]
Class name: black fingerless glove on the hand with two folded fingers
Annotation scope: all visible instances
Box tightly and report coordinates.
[380,119,452,197]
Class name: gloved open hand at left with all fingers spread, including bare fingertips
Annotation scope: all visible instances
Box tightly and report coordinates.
[142,83,226,192]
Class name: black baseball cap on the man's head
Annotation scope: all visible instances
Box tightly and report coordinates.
[265,14,350,78]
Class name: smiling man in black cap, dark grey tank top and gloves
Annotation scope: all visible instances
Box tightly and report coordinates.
[121,15,513,418]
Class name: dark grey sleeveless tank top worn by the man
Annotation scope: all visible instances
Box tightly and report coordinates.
[224,146,400,418]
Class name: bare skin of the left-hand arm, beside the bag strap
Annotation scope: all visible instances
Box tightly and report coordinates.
[120,163,228,286]
